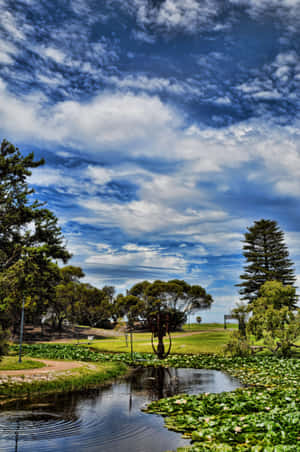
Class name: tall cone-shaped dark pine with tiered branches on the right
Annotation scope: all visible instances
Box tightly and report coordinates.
[237,219,296,308]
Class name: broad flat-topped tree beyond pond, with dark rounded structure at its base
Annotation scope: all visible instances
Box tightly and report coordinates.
[117,279,213,359]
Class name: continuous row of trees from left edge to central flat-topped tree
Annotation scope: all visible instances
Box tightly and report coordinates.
[0,140,213,355]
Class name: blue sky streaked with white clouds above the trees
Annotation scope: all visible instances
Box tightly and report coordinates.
[0,0,300,321]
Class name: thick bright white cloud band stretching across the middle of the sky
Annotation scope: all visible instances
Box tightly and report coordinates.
[0,73,300,209]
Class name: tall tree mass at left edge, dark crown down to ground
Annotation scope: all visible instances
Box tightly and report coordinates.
[0,140,71,344]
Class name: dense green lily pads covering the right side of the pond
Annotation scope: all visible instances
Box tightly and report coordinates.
[147,356,300,452]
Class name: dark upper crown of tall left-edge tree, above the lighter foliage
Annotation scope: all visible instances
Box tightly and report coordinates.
[0,140,71,271]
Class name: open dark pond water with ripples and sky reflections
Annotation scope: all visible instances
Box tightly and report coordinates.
[0,368,240,452]
